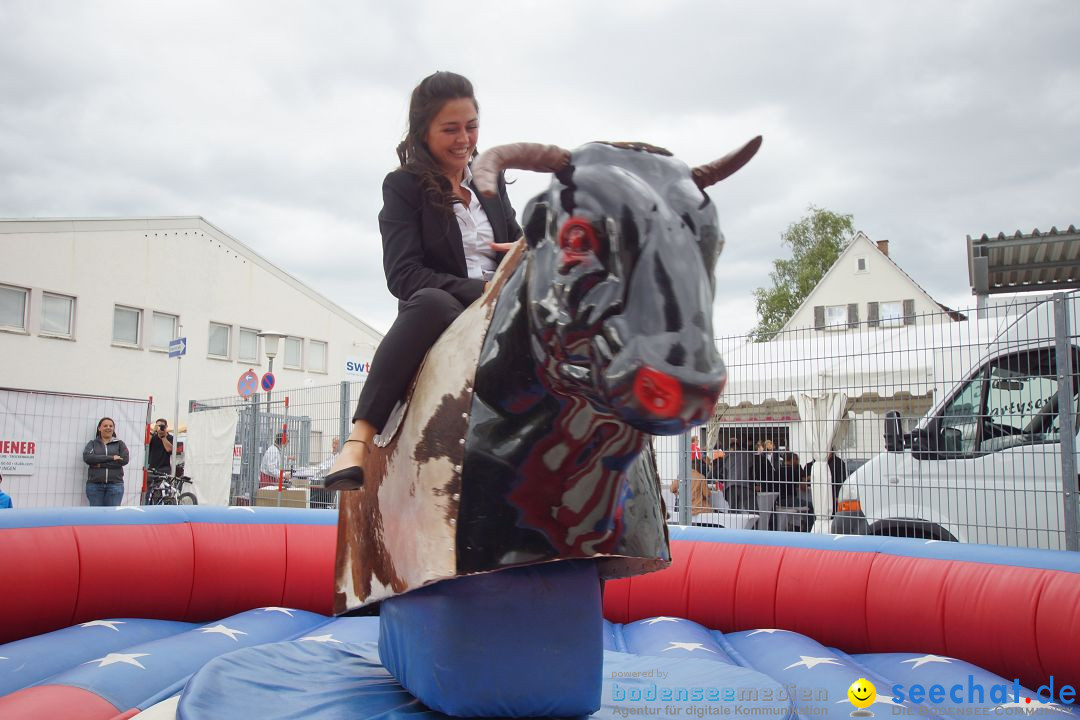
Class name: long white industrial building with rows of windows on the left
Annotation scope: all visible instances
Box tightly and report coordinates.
[0,217,382,425]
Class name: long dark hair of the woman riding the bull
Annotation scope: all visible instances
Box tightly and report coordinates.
[397,71,480,212]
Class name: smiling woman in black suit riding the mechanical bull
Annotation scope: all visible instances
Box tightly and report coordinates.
[324,72,522,490]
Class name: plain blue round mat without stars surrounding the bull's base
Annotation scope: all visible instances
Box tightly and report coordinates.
[177,634,794,720]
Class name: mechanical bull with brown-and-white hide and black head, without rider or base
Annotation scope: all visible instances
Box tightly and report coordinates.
[336,137,760,612]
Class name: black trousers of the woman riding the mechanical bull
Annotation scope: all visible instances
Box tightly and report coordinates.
[352,287,464,432]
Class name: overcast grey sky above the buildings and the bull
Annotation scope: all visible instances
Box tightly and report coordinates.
[0,0,1080,335]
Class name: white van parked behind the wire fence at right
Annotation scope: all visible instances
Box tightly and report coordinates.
[832,294,1080,548]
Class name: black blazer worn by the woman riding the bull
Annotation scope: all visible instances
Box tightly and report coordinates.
[379,168,522,305]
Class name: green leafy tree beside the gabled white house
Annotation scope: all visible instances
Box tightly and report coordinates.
[752,205,855,342]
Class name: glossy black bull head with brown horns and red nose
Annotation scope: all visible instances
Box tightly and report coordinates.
[473,137,761,435]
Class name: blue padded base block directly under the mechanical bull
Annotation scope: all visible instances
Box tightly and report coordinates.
[379,560,604,717]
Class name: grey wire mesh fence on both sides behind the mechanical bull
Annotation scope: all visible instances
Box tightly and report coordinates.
[190,294,1080,549]
